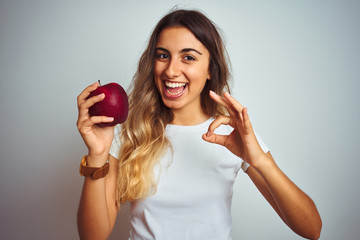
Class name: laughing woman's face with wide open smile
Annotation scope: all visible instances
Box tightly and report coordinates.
[154,27,210,114]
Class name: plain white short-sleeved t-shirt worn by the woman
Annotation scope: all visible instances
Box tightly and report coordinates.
[110,118,268,240]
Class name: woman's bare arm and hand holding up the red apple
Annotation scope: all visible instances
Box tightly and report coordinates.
[77,83,118,239]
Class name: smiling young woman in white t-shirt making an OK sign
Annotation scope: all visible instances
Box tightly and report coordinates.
[77,10,322,240]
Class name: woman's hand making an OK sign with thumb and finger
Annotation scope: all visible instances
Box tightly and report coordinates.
[203,91,266,165]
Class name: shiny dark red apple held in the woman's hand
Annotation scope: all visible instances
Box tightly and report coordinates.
[88,80,129,127]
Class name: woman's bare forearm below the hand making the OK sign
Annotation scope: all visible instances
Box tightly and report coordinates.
[254,157,321,239]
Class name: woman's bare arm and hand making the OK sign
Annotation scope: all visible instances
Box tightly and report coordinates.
[203,91,322,239]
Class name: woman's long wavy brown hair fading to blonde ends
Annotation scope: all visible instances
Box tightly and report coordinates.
[116,10,230,205]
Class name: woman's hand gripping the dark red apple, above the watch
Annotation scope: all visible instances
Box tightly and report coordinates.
[76,83,114,166]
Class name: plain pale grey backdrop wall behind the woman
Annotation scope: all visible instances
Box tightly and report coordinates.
[0,0,360,240]
